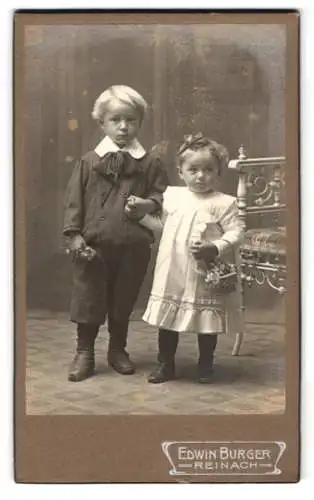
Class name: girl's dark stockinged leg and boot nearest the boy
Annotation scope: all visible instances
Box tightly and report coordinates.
[147,329,179,384]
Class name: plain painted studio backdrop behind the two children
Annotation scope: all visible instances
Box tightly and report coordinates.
[23,25,285,311]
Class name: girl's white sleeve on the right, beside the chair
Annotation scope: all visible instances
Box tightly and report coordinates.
[213,200,245,256]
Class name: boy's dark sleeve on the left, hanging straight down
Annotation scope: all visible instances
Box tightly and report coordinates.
[63,160,86,236]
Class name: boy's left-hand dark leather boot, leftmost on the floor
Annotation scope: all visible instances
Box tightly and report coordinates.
[68,324,99,382]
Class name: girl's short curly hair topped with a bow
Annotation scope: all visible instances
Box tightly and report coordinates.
[177,132,229,175]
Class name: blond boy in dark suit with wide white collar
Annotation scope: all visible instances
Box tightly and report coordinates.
[63,85,167,381]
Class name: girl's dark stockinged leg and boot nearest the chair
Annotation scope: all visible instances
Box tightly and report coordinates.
[198,334,217,384]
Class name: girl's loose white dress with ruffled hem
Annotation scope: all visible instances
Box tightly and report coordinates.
[143,187,243,333]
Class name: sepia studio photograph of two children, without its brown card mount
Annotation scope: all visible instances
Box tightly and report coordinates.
[19,18,287,416]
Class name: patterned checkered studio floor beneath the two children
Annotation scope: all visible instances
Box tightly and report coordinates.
[26,311,285,415]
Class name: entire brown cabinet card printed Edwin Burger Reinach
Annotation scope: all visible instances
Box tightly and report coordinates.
[14,11,300,483]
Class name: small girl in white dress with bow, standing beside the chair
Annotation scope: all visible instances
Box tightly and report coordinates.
[143,134,244,383]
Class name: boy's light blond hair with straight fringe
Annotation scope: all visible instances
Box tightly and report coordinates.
[92,85,148,121]
